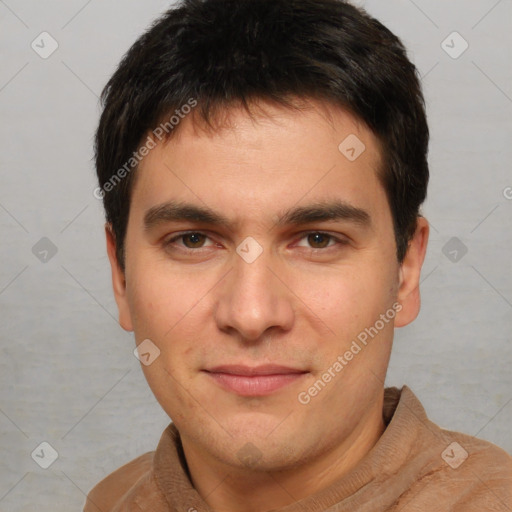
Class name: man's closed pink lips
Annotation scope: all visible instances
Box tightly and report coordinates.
[203,365,309,396]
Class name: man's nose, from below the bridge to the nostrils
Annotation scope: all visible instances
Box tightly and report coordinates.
[214,251,294,343]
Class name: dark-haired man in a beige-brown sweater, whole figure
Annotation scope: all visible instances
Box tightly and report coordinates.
[85,0,512,512]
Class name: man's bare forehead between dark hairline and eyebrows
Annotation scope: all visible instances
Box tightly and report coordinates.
[132,102,387,228]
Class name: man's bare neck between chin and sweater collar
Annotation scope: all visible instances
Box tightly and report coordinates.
[182,395,386,512]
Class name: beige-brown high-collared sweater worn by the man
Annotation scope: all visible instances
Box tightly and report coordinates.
[84,386,512,512]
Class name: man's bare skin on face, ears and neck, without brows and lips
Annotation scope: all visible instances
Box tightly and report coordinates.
[106,101,429,512]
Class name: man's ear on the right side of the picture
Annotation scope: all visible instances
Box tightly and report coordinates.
[395,217,430,327]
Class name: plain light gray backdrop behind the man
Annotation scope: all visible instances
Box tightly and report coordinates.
[0,0,512,512]
